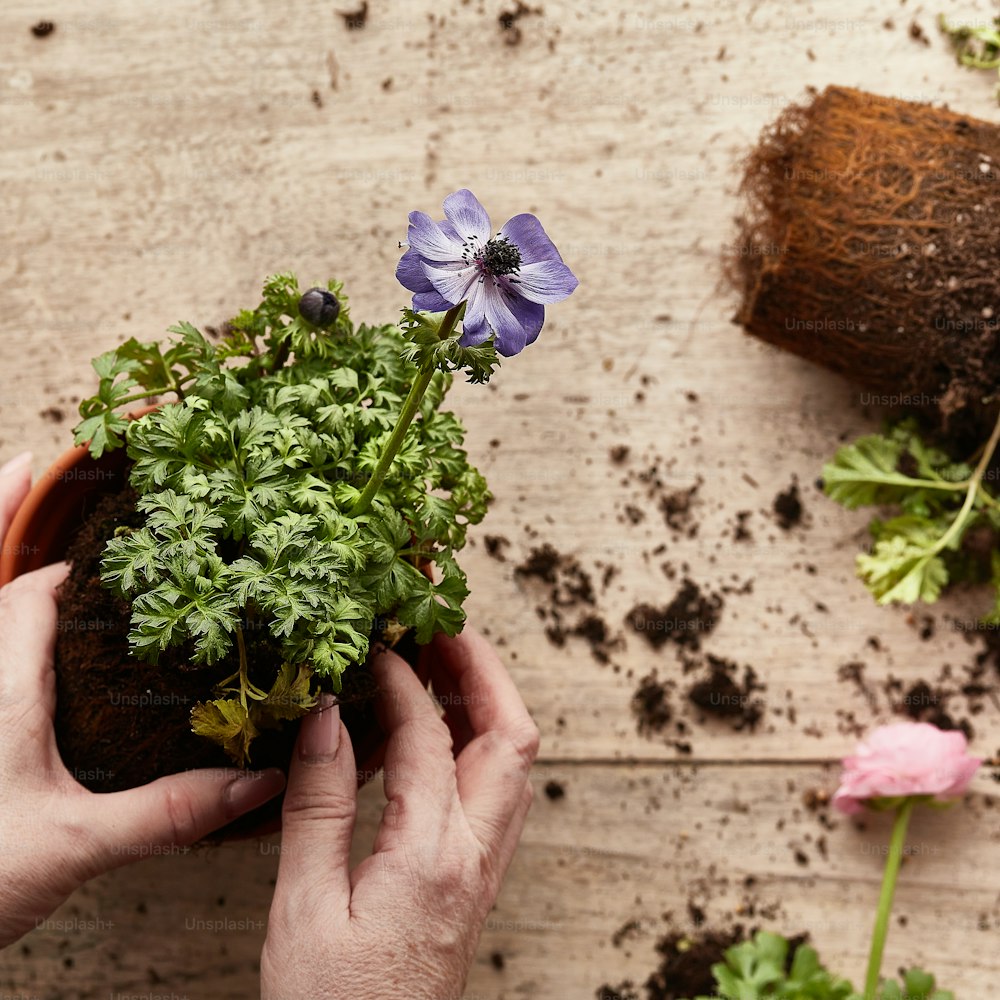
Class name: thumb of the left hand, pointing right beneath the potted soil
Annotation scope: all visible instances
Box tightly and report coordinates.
[77,768,285,871]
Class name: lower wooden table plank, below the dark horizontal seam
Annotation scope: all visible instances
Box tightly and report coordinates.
[0,764,1000,1000]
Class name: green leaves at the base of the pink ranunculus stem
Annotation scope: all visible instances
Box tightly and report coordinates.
[684,931,954,1000]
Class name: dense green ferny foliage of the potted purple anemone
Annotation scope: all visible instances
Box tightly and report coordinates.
[76,274,498,762]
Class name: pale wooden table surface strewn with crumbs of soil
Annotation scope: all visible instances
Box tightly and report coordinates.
[0,0,1000,1000]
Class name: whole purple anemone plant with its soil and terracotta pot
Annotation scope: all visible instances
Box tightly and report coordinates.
[0,190,577,822]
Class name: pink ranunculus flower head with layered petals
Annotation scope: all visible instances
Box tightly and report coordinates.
[833,722,983,814]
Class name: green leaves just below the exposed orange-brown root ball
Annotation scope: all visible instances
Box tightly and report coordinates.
[823,420,1000,616]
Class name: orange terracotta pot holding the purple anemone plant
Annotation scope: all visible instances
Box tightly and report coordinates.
[0,407,428,836]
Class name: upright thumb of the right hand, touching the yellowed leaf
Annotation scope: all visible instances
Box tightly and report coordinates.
[275,694,358,915]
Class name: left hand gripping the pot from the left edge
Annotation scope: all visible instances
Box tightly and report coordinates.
[0,454,284,947]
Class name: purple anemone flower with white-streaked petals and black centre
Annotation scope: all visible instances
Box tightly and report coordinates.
[396,188,579,357]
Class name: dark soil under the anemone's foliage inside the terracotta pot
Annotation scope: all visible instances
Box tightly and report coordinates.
[55,472,417,829]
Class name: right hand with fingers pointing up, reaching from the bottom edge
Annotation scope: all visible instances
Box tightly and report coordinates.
[261,627,538,1000]
